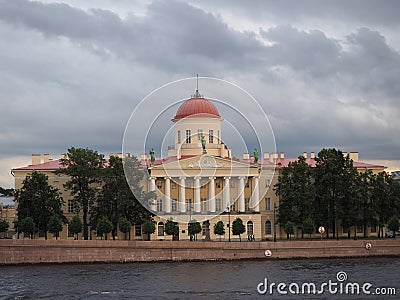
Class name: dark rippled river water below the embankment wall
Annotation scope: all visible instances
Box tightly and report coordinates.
[0,258,400,299]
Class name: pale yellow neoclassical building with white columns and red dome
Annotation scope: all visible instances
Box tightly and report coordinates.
[12,90,385,240]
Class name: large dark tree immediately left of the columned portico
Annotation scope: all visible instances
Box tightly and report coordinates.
[91,156,154,239]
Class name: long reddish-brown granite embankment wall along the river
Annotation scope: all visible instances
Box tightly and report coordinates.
[0,239,400,265]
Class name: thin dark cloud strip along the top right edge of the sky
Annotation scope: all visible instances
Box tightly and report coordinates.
[191,0,400,27]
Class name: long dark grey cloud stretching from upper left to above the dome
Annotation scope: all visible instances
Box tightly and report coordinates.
[0,0,262,71]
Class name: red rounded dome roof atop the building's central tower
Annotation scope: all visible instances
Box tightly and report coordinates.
[174,98,221,120]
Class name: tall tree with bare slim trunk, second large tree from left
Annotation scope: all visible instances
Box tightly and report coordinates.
[57,147,104,240]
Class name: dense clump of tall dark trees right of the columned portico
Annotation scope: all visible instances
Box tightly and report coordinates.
[275,149,400,237]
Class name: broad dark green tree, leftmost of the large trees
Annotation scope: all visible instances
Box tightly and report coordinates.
[15,171,67,239]
